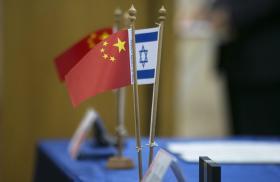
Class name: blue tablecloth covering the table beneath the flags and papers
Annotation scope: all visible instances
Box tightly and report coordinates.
[34,138,280,182]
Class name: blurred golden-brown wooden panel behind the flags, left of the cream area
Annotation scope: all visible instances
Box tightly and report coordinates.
[0,0,155,182]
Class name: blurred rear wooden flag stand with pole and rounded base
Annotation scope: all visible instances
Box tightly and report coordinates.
[107,8,134,169]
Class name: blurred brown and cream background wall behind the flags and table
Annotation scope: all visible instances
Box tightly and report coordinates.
[0,0,233,182]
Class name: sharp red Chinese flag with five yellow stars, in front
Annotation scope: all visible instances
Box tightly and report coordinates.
[65,30,131,106]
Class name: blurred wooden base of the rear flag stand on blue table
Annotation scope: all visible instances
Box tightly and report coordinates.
[107,156,134,169]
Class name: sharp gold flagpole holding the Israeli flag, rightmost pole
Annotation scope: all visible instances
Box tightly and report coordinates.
[149,6,167,166]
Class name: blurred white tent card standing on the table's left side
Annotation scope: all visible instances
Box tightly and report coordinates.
[68,109,98,159]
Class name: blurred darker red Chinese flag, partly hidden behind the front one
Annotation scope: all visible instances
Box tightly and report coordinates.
[55,28,112,81]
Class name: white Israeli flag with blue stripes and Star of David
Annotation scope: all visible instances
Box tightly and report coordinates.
[128,27,159,85]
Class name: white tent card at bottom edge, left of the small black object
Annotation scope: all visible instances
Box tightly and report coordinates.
[142,149,175,182]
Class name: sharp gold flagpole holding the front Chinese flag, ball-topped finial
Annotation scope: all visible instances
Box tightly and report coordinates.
[128,4,142,181]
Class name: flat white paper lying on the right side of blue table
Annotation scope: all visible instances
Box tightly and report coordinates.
[167,141,280,163]
